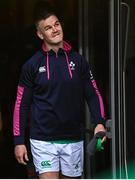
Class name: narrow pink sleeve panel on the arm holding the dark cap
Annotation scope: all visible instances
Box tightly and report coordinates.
[91,80,105,118]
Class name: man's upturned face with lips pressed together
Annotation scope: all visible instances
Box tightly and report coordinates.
[37,15,63,46]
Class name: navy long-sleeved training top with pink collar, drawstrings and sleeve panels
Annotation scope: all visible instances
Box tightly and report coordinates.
[13,42,105,145]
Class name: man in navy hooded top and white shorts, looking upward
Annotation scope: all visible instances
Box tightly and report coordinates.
[13,10,105,179]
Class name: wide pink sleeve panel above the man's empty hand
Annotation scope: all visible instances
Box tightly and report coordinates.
[13,86,24,136]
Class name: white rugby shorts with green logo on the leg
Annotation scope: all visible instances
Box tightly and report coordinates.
[30,139,84,177]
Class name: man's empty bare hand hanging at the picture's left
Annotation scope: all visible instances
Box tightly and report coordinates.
[14,144,29,165]
